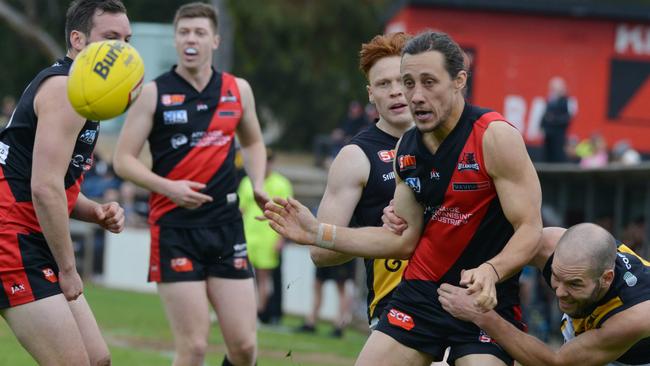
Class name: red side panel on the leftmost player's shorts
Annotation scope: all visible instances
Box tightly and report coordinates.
[0,227,35,306]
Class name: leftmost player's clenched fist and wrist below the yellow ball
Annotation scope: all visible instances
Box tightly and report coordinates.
[71,193,125,234]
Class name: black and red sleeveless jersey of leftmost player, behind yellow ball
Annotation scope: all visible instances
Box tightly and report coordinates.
[0,57,99,232]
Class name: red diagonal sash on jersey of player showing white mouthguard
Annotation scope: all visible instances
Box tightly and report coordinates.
[149,72,243,224]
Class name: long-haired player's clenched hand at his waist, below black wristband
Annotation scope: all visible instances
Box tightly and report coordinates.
[460,263,499,311]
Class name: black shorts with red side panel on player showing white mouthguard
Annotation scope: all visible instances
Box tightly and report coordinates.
[149,220,253,282]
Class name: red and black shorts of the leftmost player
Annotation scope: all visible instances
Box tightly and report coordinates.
[0,227,61,309]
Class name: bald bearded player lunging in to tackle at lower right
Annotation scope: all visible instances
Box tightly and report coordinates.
[438,224,650,366]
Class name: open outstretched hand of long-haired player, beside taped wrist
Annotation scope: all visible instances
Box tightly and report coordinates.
[264,197,318,245]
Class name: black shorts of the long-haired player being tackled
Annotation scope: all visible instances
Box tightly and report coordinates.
[375,280,526,365]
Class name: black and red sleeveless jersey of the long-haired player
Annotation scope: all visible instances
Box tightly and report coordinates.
[395,104,519,307]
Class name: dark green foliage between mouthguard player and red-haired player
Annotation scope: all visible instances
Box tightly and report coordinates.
[228,0,389,149]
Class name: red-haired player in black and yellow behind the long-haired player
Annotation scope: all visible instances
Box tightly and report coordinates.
[311,33,413,324]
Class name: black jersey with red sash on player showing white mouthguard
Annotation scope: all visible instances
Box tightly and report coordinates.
[148,66,243,227]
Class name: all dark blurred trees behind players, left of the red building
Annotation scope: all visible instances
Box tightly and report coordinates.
[0,0,394,150]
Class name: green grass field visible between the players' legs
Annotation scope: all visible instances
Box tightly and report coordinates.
[0,285,367,366]
